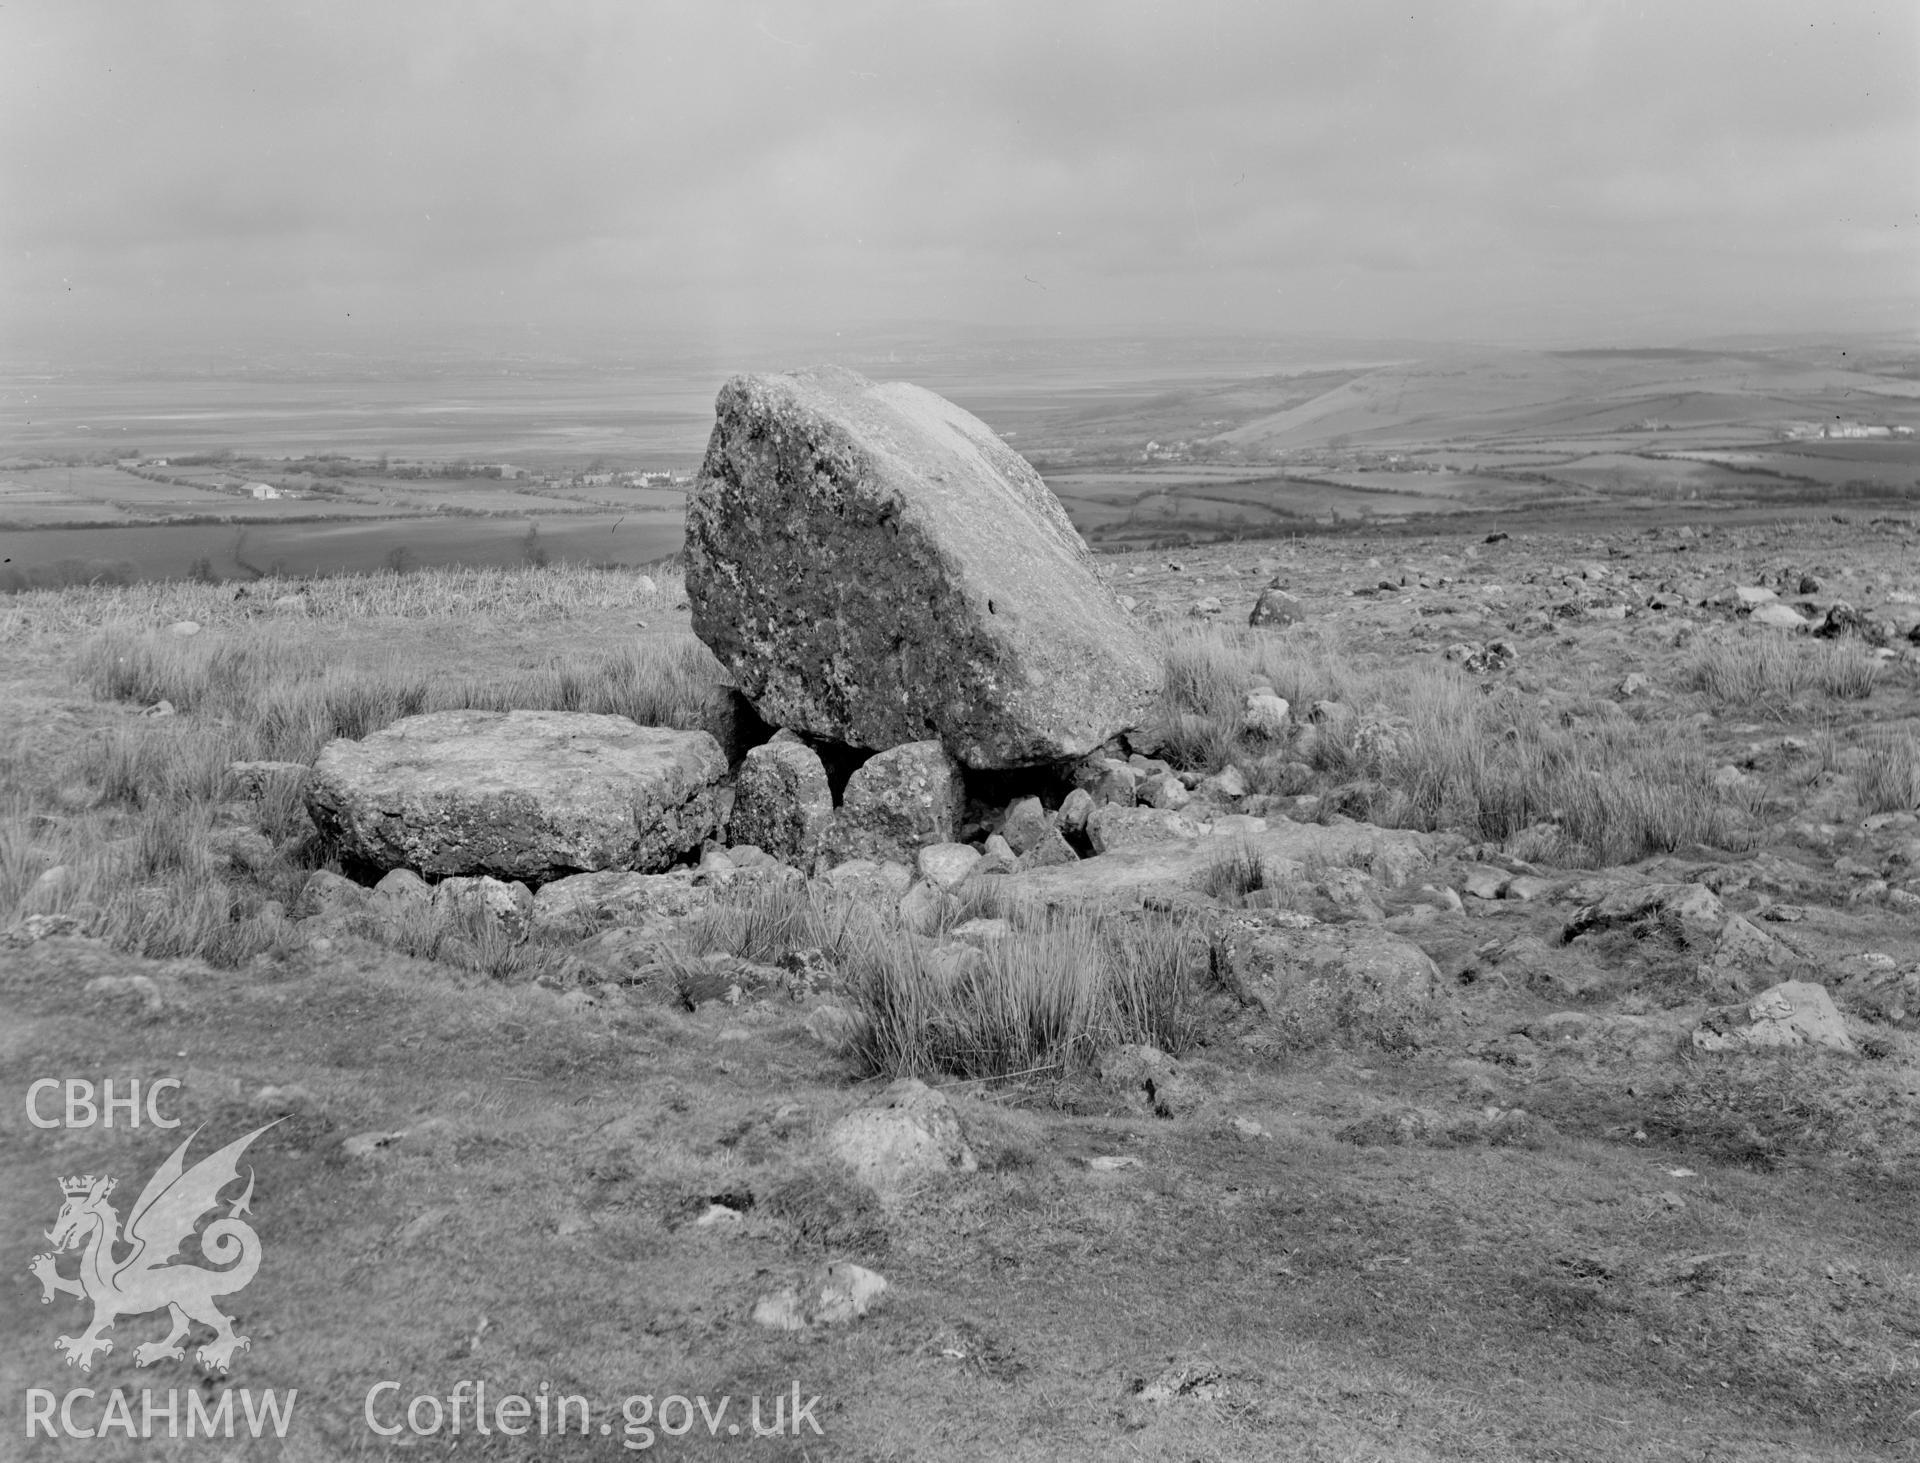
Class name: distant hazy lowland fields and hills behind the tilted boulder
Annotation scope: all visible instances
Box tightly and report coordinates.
[0,340,1920,588]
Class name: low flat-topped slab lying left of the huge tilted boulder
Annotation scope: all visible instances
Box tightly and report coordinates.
[307,710,726,883]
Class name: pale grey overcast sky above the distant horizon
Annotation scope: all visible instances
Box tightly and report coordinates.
[0,0,1920,355]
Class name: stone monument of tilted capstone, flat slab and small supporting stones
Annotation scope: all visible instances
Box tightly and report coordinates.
[307,367,1320,913]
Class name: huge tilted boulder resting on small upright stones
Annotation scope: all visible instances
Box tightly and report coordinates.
[687,367,1158,768]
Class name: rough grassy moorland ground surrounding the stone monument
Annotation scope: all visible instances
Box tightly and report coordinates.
[0,511,1920,1461]
